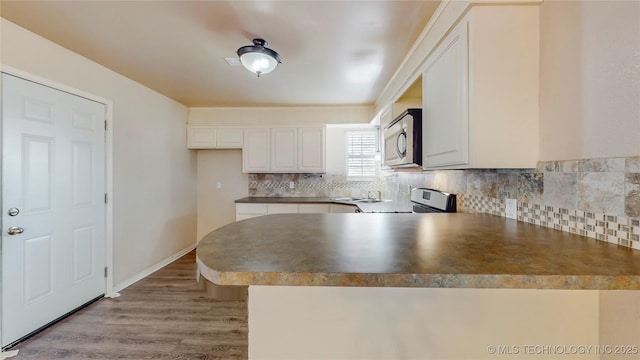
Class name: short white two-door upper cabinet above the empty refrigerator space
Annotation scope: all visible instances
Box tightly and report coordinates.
[187,125,243,149]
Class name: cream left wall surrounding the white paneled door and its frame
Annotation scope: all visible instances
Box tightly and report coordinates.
[0,19,196,287]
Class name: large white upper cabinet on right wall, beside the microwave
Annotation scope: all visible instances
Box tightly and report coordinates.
[422,5,539,169]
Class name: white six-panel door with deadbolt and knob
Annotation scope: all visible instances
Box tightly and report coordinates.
[2,74,106,346]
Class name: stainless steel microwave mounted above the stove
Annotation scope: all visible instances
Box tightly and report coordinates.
[384,109,422,167]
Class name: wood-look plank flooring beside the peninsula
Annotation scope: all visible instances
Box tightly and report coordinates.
[10,251,248,360]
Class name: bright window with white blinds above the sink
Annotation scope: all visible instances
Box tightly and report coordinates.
[347,130,378,181]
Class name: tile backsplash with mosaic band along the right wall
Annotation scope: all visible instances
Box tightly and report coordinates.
[386,157,640,249]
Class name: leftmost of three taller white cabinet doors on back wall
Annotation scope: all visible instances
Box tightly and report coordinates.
[242,128,269,173]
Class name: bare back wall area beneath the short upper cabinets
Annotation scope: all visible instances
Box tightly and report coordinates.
[197,150,249,241]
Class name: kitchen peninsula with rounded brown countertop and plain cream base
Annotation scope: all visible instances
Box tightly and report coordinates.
[197,213,640,359]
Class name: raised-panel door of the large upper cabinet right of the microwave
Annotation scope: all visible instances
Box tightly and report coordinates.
[422,21,469,168]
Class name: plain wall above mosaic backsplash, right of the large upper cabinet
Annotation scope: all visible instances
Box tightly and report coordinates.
[540,1,640,160]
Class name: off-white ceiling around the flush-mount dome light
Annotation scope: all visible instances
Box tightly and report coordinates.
[0,0,440,107]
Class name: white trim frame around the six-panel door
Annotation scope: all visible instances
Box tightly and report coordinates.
[0,64,114,300]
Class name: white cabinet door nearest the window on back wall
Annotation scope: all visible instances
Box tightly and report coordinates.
[298,127,325,173]
